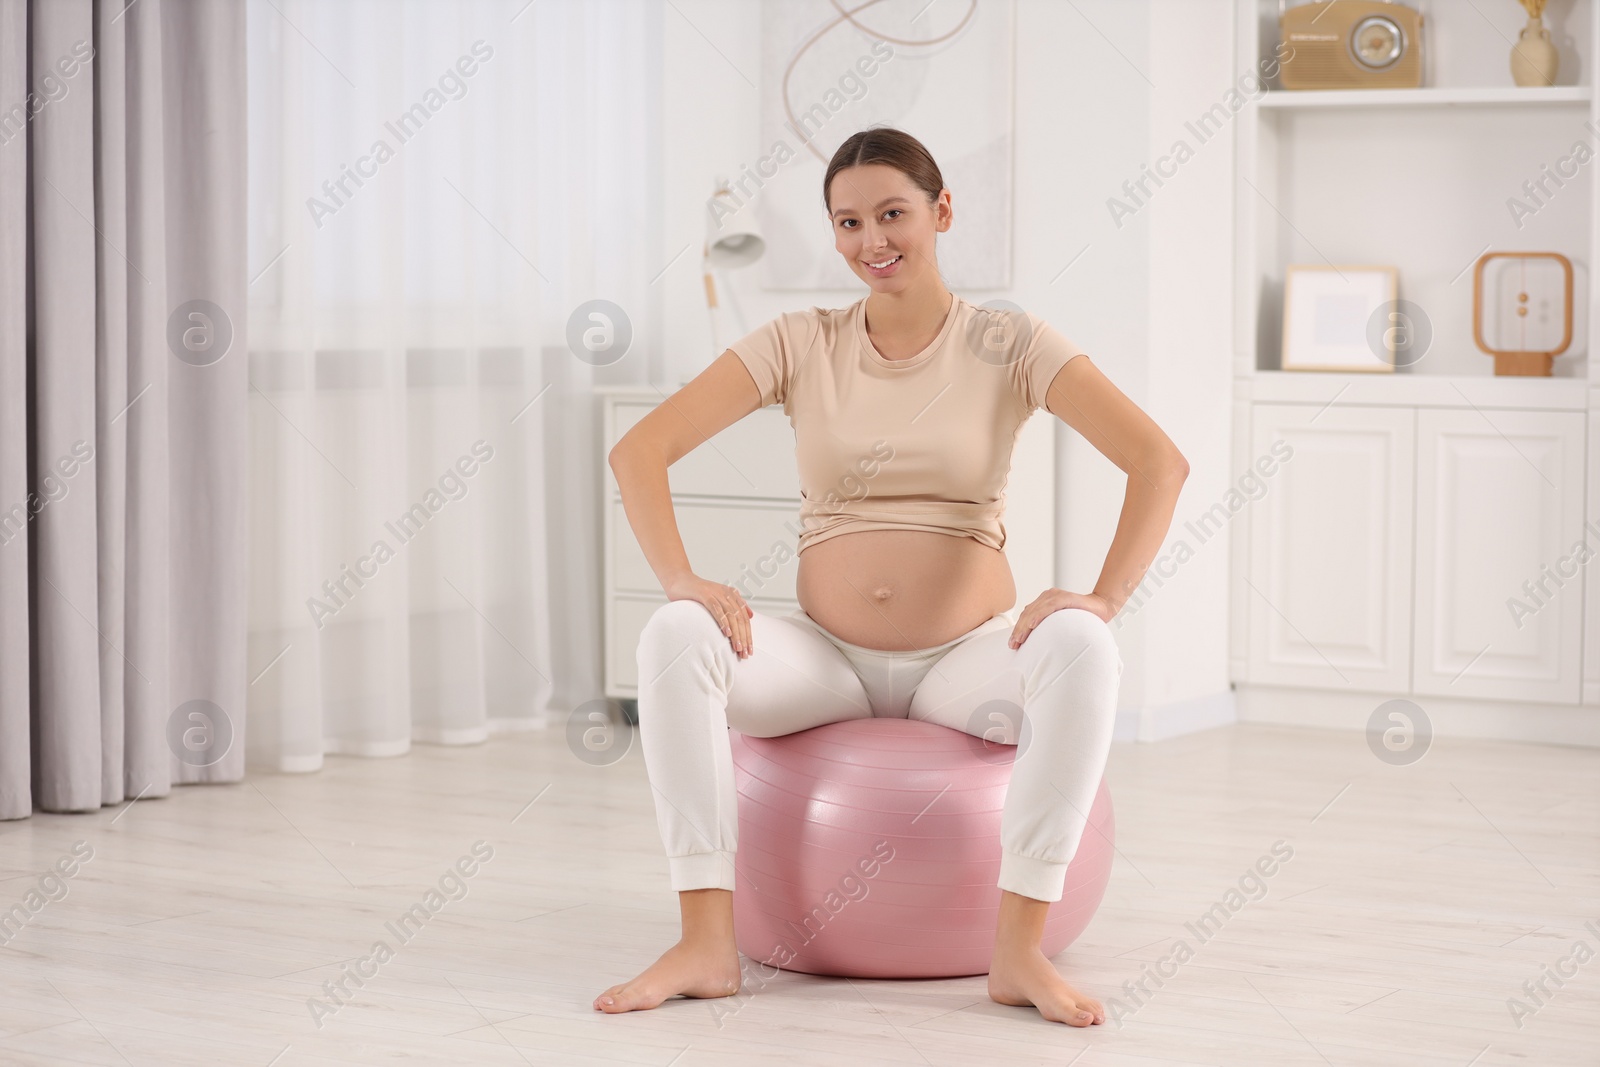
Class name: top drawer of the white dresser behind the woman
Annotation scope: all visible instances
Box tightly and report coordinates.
[606,402,800,507]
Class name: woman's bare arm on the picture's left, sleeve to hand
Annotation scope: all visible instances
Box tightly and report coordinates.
[606,349,762,656]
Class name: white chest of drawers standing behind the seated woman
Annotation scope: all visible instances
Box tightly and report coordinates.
[595,386,1058,701]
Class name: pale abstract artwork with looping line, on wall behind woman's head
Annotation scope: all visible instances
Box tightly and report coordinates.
[745,0,1016,293]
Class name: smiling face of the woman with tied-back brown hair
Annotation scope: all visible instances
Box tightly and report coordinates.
[829,163,950,293]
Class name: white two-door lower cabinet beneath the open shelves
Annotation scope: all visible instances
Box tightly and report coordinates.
[1237,396,1600,704]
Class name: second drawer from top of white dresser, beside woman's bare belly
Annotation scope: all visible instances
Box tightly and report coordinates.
[611,499,800,600]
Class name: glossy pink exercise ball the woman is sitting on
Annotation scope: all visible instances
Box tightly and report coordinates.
[730,717,1115,977]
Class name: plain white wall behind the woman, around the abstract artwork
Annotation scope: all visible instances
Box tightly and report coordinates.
[658,0,1232,734]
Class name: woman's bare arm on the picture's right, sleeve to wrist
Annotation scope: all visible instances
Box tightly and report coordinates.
[1045,355,1189,622]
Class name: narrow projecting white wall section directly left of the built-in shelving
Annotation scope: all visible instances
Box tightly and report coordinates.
[1123,0,1235,737]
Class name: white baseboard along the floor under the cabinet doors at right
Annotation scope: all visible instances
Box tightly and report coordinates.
[1235,681,1600,749]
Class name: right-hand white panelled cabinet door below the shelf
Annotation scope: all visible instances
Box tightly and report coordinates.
[1413,408,1595,704]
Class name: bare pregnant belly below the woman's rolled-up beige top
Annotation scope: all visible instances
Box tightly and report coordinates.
[795,530,1016,651]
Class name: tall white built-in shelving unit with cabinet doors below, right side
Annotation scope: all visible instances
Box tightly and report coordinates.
[1230,0,1600,744]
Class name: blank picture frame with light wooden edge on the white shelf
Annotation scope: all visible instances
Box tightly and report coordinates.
[1280,264,1400,373]
